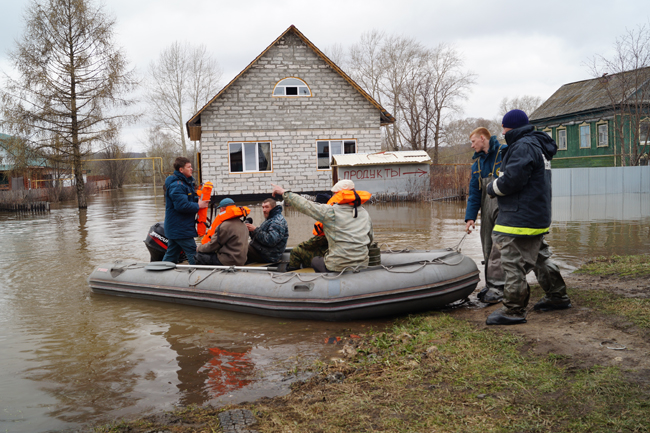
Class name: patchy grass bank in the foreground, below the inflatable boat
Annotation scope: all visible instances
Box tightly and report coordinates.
[249,313,650,432]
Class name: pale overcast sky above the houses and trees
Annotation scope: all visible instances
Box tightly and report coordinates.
[0,0,650,150]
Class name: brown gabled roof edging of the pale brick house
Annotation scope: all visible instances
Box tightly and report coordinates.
[185,24,395,135]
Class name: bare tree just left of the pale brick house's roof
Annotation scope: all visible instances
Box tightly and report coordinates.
[146,42,221,155]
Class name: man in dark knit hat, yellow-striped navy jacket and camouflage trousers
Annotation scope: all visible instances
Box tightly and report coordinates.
[486,110,571,325]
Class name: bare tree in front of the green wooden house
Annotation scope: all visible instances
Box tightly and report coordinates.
[589,25,650,165]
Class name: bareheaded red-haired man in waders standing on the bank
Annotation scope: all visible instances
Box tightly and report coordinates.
[465,128,508,304]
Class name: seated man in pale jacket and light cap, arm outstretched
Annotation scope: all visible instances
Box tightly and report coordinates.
[273,180,373,272]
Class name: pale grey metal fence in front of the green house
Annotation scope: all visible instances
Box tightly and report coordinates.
[553,166,650,198]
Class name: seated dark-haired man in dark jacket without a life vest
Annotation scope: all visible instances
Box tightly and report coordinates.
[246,198,289,263]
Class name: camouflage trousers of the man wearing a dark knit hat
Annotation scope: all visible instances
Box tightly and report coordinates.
[492,233,569,314]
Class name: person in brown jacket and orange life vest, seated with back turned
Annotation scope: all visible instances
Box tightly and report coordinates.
[196,198,248,266]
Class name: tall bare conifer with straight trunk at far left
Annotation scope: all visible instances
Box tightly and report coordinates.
[2,0,136,209]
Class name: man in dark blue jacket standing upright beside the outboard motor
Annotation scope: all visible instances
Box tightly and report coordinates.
[163,156,209,265]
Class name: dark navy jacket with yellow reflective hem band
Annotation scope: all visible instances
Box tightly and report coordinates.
[487,125,557,236]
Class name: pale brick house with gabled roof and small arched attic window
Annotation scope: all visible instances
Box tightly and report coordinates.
[186,26,395,198]
